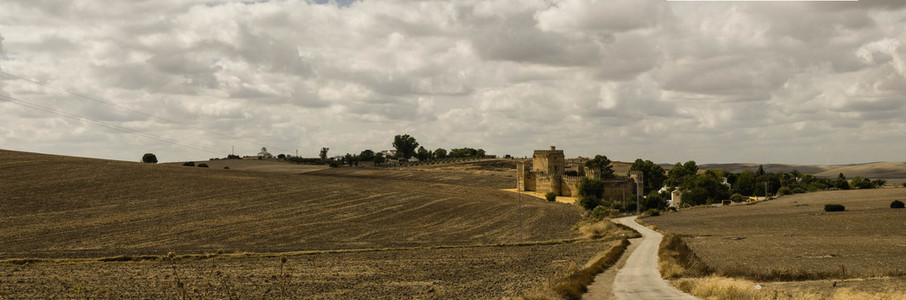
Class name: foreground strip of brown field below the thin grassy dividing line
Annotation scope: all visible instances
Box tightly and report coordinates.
[0,242,610,299]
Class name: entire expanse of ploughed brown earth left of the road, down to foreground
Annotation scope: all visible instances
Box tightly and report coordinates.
[0,150,610,298]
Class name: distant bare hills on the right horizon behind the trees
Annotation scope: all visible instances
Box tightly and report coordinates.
[699,162,906,179]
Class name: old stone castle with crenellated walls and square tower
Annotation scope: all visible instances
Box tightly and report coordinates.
[516,146,644,201]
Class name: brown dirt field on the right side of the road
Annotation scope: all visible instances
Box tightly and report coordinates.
[645,188,906,280]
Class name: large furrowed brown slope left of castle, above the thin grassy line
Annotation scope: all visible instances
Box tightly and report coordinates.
[0,151,580,258]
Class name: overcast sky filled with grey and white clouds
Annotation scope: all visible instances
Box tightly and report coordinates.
[0,0,906,164]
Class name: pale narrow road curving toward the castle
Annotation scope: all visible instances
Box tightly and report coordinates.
[613,217,697,299]
